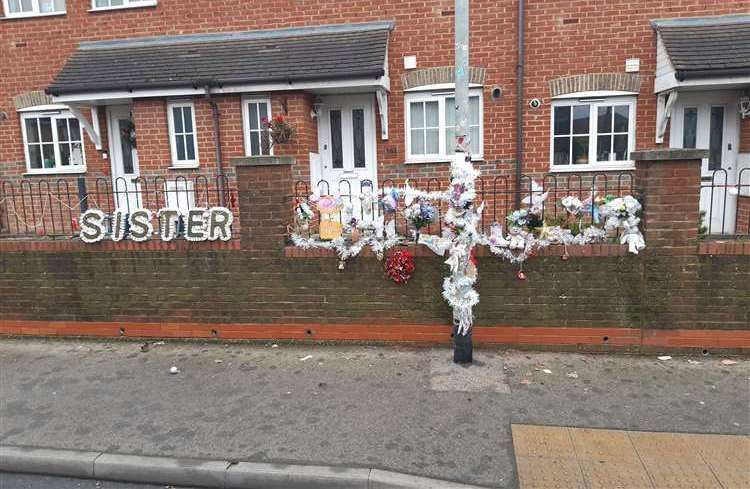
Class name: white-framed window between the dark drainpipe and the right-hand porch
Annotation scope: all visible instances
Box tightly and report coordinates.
[551,97,635,171]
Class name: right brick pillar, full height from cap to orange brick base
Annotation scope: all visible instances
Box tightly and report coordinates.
[631,149,708,330]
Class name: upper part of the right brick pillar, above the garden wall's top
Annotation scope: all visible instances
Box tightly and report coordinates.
[631,149,708,255]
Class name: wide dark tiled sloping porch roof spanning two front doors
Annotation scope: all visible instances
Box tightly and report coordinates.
[47,22,393,101]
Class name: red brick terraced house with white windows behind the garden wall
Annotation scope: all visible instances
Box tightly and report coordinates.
[0,0,750,234]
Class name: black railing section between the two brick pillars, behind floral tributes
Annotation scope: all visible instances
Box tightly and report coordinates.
[293,172,635,234]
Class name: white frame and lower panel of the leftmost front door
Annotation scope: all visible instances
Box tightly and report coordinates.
[107,105,141,211]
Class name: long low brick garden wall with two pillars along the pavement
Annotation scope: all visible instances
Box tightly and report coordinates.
[0,151,750,350]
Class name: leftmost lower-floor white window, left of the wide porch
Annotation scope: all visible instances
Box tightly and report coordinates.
[21,112,86,173]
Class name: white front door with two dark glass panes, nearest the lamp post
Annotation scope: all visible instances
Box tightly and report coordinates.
[311,94,377,197]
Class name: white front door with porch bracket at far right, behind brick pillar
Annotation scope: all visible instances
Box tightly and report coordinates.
[669,90,740,234]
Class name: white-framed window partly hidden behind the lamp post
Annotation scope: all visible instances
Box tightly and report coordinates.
[405,89,484,162]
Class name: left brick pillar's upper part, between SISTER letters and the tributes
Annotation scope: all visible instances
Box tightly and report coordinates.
[231,156,294,255]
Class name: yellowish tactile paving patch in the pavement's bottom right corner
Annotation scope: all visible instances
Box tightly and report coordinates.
[512,425,750,489]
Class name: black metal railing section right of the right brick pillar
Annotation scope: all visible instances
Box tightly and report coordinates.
[700,168,750,238]
